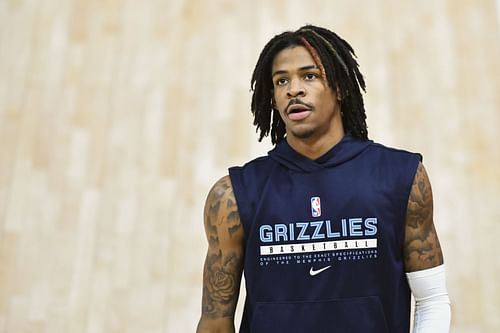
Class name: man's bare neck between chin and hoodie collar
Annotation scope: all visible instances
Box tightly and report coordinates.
[286,125,345,160]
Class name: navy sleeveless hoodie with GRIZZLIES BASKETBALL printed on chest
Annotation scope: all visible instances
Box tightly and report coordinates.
[229,135,421,333]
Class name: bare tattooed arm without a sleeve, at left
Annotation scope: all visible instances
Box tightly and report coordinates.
[196,176,244,333]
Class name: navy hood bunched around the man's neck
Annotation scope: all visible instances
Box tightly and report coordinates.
[268,134,372,173]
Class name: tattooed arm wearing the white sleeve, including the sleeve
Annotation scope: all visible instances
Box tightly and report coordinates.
[404,164,451,333]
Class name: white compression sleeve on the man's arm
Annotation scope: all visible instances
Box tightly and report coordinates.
[406,264,451,333]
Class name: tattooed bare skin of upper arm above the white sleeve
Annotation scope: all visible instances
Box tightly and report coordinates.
[404,164,443,272]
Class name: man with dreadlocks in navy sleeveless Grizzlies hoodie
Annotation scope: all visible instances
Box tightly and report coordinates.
[197,25,450,333]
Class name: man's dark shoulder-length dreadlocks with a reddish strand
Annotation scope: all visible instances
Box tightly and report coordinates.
[251,25,368,144]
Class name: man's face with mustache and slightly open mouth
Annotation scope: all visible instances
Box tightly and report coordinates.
[272,46,343,140]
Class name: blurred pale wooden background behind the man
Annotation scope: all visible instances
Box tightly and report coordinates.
[0,0,500,333]
